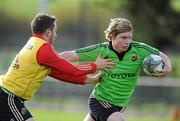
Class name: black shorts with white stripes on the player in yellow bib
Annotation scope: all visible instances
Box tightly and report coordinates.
[0,87,32,121]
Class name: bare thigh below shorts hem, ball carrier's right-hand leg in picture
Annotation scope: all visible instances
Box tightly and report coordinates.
[107,112,125,121]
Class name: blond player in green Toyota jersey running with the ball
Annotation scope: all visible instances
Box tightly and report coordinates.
[60,18,172,121]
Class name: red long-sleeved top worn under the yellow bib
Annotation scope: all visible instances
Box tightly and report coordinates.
[33,34,97,84]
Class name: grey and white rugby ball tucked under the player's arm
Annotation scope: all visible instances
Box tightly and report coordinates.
[142,54,164,75]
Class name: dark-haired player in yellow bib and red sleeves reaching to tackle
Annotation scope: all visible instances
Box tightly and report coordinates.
[0,14,113,121]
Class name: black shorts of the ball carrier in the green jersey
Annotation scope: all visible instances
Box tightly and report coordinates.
[89,96,125,121]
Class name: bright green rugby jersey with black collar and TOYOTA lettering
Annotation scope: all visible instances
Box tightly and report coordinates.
[76,41,159,106]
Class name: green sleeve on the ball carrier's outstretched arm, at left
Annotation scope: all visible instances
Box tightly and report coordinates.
[75,44,102,61]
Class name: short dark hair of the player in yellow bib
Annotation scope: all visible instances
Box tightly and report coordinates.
[31,13,56,34]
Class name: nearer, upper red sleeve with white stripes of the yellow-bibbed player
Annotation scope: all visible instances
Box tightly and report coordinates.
[36,43,96,76]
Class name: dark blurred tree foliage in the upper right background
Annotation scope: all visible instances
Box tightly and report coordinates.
[127,0,180,49]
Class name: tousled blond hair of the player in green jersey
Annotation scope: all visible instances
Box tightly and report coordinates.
[104,18,133,41]
